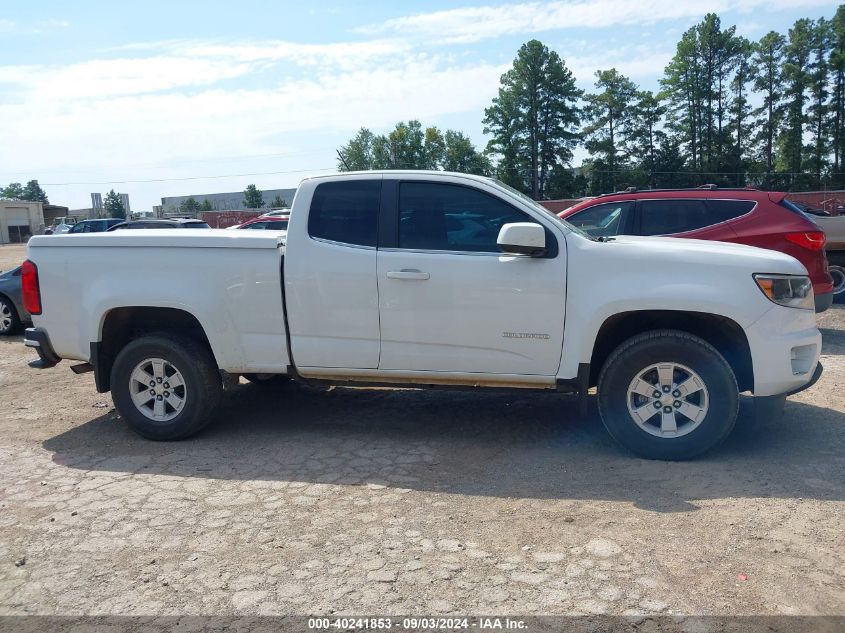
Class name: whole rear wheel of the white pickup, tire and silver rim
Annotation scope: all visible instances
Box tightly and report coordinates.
[111,333,223,440]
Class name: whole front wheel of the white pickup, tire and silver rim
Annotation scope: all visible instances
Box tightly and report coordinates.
[598,330,739,460]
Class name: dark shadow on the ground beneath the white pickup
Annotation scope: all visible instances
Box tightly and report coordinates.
[43,384,845,512]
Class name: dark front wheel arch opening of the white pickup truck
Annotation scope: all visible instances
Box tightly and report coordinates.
[589,310,754,391]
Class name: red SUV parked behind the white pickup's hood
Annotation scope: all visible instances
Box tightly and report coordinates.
[558,185,833,312]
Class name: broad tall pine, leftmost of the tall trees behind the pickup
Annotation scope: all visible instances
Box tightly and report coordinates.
[483,40,582,199]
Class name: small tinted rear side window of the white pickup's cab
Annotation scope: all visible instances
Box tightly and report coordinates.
[308,180,381,246]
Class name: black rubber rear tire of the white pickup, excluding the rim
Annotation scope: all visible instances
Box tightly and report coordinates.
[111,332,223,440]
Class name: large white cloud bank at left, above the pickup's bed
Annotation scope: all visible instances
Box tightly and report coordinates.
[0,41,505,208]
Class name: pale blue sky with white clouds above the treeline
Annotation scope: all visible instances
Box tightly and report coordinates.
[0,0,836,211]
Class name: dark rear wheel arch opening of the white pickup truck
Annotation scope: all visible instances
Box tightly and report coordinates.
[95,306,219,393]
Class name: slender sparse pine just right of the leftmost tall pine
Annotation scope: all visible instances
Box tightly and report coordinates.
[583,68,637,191]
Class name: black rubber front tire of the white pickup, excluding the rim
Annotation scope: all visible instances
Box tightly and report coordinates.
[598,330,739,460]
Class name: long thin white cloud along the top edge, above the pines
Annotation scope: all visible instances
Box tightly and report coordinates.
[359,0,830,43]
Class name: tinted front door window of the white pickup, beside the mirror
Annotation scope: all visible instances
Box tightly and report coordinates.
[399,182,534,253]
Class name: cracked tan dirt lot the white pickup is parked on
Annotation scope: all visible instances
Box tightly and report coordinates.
[0,247,845,615]
